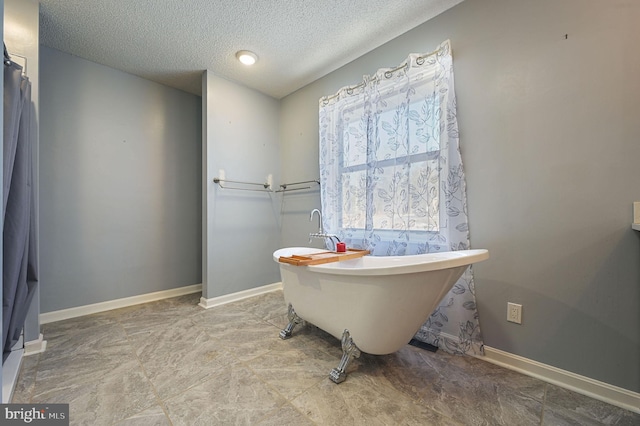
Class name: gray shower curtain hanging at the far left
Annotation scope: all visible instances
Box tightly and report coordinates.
[2,50,38,362]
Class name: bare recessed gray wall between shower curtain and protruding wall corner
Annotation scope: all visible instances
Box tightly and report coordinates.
[40,47,202,312]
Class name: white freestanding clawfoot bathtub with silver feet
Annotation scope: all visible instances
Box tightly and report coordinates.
[273,247,489,383]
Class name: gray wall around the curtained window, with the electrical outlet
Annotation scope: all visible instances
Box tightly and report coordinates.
[281,0,640,392]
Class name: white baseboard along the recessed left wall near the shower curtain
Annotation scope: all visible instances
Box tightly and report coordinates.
[40,284,202,324]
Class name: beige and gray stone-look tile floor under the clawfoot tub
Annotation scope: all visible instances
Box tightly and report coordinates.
[13,291,640,426]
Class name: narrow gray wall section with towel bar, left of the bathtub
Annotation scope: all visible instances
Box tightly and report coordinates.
[202,71,280,299]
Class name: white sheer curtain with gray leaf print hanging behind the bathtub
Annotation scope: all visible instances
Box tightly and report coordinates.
[320,40,483,353]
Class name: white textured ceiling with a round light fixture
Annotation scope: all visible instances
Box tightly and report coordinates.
[40,0,462,98]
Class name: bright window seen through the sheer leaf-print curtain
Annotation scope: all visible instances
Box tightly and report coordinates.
[339,79,440,232]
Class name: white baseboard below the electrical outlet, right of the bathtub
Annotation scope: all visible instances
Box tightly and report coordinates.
[478,346,640,413]
